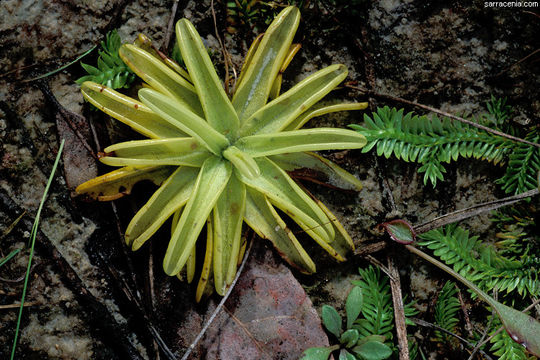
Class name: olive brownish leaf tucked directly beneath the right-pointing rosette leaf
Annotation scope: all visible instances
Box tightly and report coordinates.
[269,152,362,191]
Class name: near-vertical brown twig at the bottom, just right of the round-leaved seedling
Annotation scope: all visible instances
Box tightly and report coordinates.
[386,256,410,360]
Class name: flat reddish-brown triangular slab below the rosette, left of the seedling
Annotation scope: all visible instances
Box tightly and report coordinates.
[178,242,329,360]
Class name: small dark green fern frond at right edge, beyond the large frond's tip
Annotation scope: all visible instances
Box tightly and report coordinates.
[495,129,540,194]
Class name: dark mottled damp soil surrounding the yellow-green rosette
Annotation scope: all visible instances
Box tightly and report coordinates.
[0,0,540,360]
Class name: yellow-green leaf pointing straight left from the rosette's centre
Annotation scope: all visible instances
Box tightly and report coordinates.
[100,137,212,167]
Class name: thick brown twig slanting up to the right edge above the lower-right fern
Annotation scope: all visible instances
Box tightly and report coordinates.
[414,189,538,234]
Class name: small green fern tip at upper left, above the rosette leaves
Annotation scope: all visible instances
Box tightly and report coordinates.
[75,30,135,89]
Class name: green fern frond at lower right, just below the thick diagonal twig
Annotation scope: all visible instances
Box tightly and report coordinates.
[419,224,540,296]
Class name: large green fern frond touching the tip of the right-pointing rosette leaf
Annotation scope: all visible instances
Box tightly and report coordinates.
[350,106,510,187]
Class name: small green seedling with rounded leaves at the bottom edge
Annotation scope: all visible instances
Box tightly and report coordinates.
[302,286,392,360]
